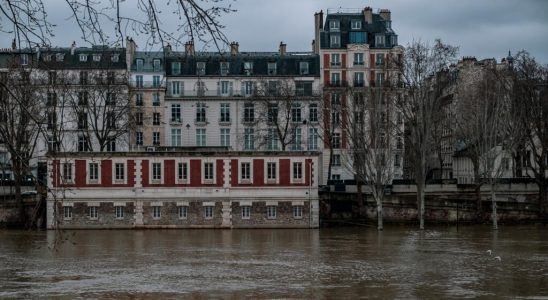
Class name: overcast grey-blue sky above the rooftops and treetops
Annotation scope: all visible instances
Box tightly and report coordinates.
[0,0,548,63]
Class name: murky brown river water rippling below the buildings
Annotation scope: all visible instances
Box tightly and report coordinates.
[0,226,548,300]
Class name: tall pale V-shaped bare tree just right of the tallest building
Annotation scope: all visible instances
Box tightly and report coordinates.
[395,40,458,229]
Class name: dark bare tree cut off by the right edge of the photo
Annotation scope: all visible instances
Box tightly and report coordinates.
[512,51,548,217]
